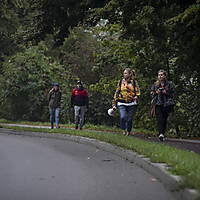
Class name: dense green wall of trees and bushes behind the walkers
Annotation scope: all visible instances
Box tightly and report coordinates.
[0,0,200,137]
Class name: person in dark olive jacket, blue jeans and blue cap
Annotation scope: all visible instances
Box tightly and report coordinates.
[48,83,62,129]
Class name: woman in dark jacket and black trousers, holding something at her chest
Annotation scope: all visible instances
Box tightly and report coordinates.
[151,69,175,141]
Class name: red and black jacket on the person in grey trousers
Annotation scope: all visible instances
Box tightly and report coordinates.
[71,87,88,107]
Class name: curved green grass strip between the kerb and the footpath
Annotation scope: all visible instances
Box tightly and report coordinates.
[2,125,200,196]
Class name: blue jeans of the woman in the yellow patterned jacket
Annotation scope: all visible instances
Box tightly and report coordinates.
[118,105,137,132]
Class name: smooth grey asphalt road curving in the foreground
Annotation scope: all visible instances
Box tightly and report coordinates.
[0,130,174,200]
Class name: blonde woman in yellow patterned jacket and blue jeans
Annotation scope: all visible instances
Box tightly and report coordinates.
[112,68,140,135]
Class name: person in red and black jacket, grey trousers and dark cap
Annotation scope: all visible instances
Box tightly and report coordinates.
[71,81,88,130]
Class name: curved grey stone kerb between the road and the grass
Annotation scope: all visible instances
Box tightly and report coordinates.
[0,128,198,200]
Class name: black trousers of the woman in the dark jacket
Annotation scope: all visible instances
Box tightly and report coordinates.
[155,105,169,135]
